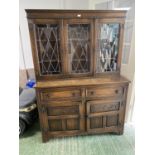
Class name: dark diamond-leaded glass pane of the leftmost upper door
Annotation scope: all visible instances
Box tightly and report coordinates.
[36,24,62,75]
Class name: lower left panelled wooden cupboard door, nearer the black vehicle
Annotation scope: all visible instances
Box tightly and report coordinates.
[46,101,85,135]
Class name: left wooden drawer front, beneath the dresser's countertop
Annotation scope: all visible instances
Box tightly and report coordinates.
[41,89,81,101]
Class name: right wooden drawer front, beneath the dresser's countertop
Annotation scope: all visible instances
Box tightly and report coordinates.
[86,87,123,97]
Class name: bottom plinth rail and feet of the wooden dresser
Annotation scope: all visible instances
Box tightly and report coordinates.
[42,127,124,143]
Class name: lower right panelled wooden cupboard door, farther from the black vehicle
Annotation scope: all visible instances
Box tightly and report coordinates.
[87,100,122,132]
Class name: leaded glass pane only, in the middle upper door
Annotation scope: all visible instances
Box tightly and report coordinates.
[68,24,90,73]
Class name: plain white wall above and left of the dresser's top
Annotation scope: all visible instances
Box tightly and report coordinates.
[19,0,89,69]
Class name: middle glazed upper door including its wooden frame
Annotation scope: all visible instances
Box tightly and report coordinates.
[64,19,94,76]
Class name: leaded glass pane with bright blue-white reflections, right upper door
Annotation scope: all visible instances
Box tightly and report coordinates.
[96,23,119,73]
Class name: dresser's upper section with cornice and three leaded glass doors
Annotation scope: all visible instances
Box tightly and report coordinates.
[27,10,125,80]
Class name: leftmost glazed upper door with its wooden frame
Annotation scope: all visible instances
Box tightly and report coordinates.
[29,19,64,79]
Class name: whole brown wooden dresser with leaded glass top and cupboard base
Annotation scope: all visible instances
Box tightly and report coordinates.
[26,10,129,142]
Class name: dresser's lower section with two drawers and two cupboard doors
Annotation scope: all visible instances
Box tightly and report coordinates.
[37,83,128,142]
